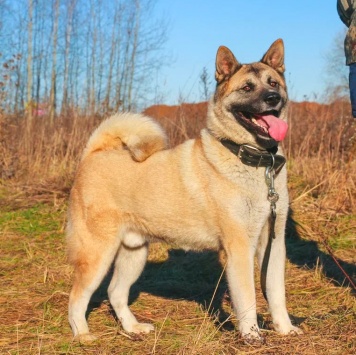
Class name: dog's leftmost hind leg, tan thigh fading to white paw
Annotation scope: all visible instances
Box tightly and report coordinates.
[68,229,120,342]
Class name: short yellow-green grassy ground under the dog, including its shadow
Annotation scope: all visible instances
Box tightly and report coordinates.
[0,203,356,354]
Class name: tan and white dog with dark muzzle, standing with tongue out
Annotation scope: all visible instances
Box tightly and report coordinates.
[66,39,302,341]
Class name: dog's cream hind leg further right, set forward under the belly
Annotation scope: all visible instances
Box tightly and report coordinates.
[109,233,154,333]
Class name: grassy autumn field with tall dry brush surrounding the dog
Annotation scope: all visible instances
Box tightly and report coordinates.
[0,101,356,355]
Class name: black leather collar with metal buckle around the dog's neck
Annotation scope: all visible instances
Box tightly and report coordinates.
[220,139,286,174]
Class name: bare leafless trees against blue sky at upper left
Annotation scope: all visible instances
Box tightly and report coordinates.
[0,0,167,120]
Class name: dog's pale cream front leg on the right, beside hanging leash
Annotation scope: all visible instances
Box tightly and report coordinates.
[257,220,302,334]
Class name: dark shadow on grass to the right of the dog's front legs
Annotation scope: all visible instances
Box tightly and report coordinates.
[286,209,356,294]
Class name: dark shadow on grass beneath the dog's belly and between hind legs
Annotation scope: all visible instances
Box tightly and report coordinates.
[87,249,235,330]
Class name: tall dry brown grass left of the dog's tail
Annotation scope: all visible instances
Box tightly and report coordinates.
[0,112,100,206]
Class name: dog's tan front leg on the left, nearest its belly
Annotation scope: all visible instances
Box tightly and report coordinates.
[224,234,261,342]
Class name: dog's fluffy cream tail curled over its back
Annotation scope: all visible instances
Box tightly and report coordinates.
[82,113,167,162]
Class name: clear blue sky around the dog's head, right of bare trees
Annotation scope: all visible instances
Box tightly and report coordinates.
[155,0,347,104]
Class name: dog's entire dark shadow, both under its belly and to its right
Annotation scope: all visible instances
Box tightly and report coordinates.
[88,210,356,330]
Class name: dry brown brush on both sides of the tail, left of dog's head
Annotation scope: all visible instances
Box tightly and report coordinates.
[0,103,207,186]
